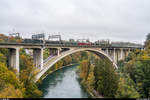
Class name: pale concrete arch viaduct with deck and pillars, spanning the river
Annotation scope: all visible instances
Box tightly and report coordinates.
[0,43,143,81]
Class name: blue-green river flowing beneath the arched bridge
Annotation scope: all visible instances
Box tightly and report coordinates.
[39,65,89,98]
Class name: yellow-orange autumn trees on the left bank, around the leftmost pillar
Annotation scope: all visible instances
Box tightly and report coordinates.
[0,49,42,98]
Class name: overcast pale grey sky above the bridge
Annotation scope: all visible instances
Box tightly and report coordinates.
[0,0,150,44]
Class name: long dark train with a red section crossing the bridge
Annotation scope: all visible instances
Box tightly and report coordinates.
[22,39,111,46]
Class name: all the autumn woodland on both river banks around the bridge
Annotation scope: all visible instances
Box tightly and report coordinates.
[0,34,150,98]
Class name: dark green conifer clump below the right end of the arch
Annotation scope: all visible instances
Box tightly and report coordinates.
[94,59,119,97]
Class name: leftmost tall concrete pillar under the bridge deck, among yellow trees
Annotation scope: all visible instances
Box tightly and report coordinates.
[9,48,19,73]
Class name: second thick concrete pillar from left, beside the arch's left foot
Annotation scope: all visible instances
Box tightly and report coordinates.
[33,48,43,69]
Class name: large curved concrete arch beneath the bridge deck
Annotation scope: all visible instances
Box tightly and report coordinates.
[36,48,118,81]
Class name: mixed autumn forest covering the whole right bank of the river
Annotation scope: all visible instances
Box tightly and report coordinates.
[79,33,150,98]
